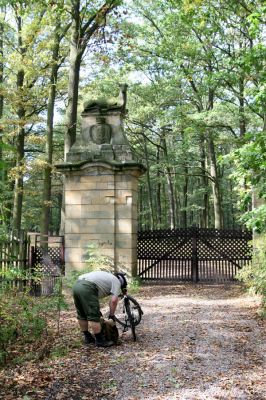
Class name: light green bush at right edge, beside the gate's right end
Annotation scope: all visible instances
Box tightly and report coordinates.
[237,235,266,318]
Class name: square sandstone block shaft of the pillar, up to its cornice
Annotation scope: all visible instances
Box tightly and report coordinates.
[57,162,147,275]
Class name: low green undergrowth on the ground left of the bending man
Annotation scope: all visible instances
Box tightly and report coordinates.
[0,271,67,364]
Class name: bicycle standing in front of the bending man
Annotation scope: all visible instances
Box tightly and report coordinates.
[115,289,143,342]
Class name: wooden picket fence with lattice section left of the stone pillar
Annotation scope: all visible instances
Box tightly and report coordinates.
[0,232,64,296]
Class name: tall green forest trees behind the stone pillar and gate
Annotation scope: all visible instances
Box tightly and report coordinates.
[0,0,266,235]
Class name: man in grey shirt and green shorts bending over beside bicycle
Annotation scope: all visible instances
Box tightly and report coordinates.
[73,271,127,347]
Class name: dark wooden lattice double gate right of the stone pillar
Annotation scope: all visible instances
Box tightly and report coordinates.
[138,228,252,282]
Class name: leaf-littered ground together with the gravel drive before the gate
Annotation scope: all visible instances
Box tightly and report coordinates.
[1,285,266,400]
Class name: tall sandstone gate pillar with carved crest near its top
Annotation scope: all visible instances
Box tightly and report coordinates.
[56,86,145,276]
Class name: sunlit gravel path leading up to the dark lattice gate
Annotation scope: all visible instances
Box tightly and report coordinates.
[98,286,266,400]
